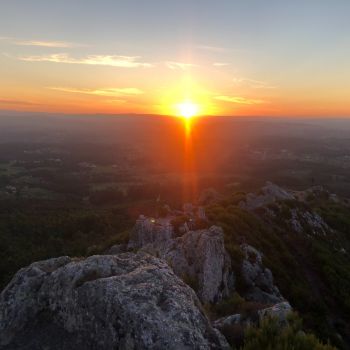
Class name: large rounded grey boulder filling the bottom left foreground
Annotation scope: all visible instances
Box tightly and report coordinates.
[0,253,228,350]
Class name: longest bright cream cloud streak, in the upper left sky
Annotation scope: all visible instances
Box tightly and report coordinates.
[18,53,152,68]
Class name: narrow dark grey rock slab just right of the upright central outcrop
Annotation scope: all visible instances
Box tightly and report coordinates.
[241,244,284,304]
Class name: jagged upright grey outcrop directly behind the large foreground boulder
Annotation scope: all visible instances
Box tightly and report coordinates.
[129,220,234,302]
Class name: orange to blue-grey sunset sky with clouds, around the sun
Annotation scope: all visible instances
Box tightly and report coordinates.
[0,0,350,117]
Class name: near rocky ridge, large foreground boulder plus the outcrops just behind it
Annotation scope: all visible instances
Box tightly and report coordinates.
[0,196,291,350]
